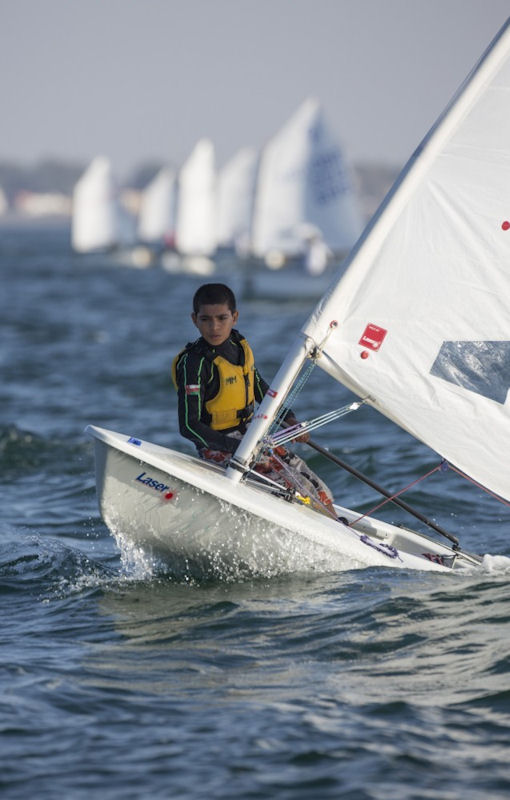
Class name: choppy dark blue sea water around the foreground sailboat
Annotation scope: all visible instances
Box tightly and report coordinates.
[0,220,510,800]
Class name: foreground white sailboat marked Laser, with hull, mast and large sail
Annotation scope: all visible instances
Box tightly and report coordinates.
[84,20,510,574]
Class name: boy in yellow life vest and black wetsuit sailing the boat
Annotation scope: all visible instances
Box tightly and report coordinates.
[172,283,334,514]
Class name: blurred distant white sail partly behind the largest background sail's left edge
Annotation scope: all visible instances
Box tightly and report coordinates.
[218,147,258,247]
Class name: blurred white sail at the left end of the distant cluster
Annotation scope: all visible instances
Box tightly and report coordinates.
[71,156,133,253]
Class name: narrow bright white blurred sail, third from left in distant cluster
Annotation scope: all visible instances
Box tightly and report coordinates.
[176,139,216,256]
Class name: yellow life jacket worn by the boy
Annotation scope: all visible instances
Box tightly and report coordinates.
[172,339,255,431]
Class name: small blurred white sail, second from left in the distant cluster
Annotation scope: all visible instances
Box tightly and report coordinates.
[138,167,177,243]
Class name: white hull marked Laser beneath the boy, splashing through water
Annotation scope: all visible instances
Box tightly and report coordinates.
[87,426,477,578]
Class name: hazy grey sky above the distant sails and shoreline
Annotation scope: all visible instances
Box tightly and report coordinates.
[0,0,510,177]
